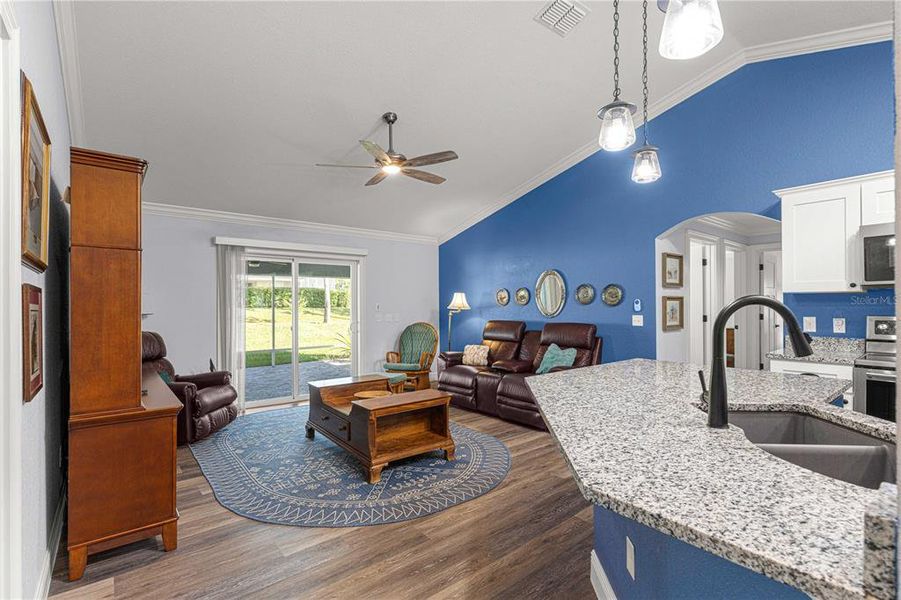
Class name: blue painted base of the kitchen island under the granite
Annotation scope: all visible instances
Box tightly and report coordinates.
[594,506,808,600]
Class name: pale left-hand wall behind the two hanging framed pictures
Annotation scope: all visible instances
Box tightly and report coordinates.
[13,2,69,597]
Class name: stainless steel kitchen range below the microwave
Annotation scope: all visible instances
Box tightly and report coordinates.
[854,317,897,421]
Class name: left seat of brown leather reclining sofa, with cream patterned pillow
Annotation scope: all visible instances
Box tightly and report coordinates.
[438,321,526,414]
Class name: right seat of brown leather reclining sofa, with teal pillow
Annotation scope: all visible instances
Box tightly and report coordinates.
[495,323,603,429]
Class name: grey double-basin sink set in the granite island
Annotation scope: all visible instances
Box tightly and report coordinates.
[729,411,896,488]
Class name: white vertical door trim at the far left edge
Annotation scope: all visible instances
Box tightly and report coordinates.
[0,0,22,598]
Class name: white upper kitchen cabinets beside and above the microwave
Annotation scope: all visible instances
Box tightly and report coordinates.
[775,171,895,292]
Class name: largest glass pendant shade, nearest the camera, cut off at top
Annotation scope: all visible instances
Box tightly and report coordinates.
[659,0,723,60]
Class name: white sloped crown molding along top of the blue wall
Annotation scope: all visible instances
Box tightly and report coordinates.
[438,21,892,244]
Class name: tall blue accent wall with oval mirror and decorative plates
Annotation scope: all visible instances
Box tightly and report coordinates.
[439,42,894,362]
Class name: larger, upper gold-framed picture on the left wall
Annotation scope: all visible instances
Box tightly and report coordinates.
[22,73,50,273]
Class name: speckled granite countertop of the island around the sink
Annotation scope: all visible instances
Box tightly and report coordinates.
[526,359,895,598]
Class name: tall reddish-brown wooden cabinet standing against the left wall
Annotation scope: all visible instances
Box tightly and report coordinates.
[68,148,181,580]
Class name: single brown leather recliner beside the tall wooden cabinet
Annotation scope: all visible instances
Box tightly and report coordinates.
[141,331,238,445]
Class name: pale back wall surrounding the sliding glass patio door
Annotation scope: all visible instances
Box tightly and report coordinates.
[143,212,438,380]
